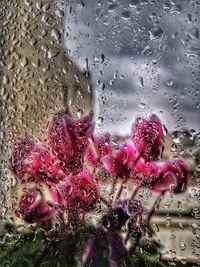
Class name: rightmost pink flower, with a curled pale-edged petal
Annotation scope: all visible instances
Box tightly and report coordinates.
[151,159,189,193]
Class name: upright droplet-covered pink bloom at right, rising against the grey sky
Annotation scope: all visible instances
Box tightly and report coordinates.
[132,115,164,161]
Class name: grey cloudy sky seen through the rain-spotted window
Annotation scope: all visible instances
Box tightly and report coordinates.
[61,0,200,135]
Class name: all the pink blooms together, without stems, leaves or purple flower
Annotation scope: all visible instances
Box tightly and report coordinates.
[10,112,191,226]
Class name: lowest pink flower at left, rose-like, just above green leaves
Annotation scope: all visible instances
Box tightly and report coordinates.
[19,188,55,223]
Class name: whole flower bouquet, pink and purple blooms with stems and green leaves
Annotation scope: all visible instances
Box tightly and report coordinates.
[0,112,188,267]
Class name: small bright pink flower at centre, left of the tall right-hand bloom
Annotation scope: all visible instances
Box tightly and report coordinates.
[103,142,137,178]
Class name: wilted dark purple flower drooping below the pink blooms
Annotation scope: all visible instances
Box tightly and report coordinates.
[82,199,147,267]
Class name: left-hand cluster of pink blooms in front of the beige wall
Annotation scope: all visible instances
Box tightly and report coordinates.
[10,112,98,223]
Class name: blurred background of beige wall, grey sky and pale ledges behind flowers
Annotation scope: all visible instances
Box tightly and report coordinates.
[0,0,200,266]
